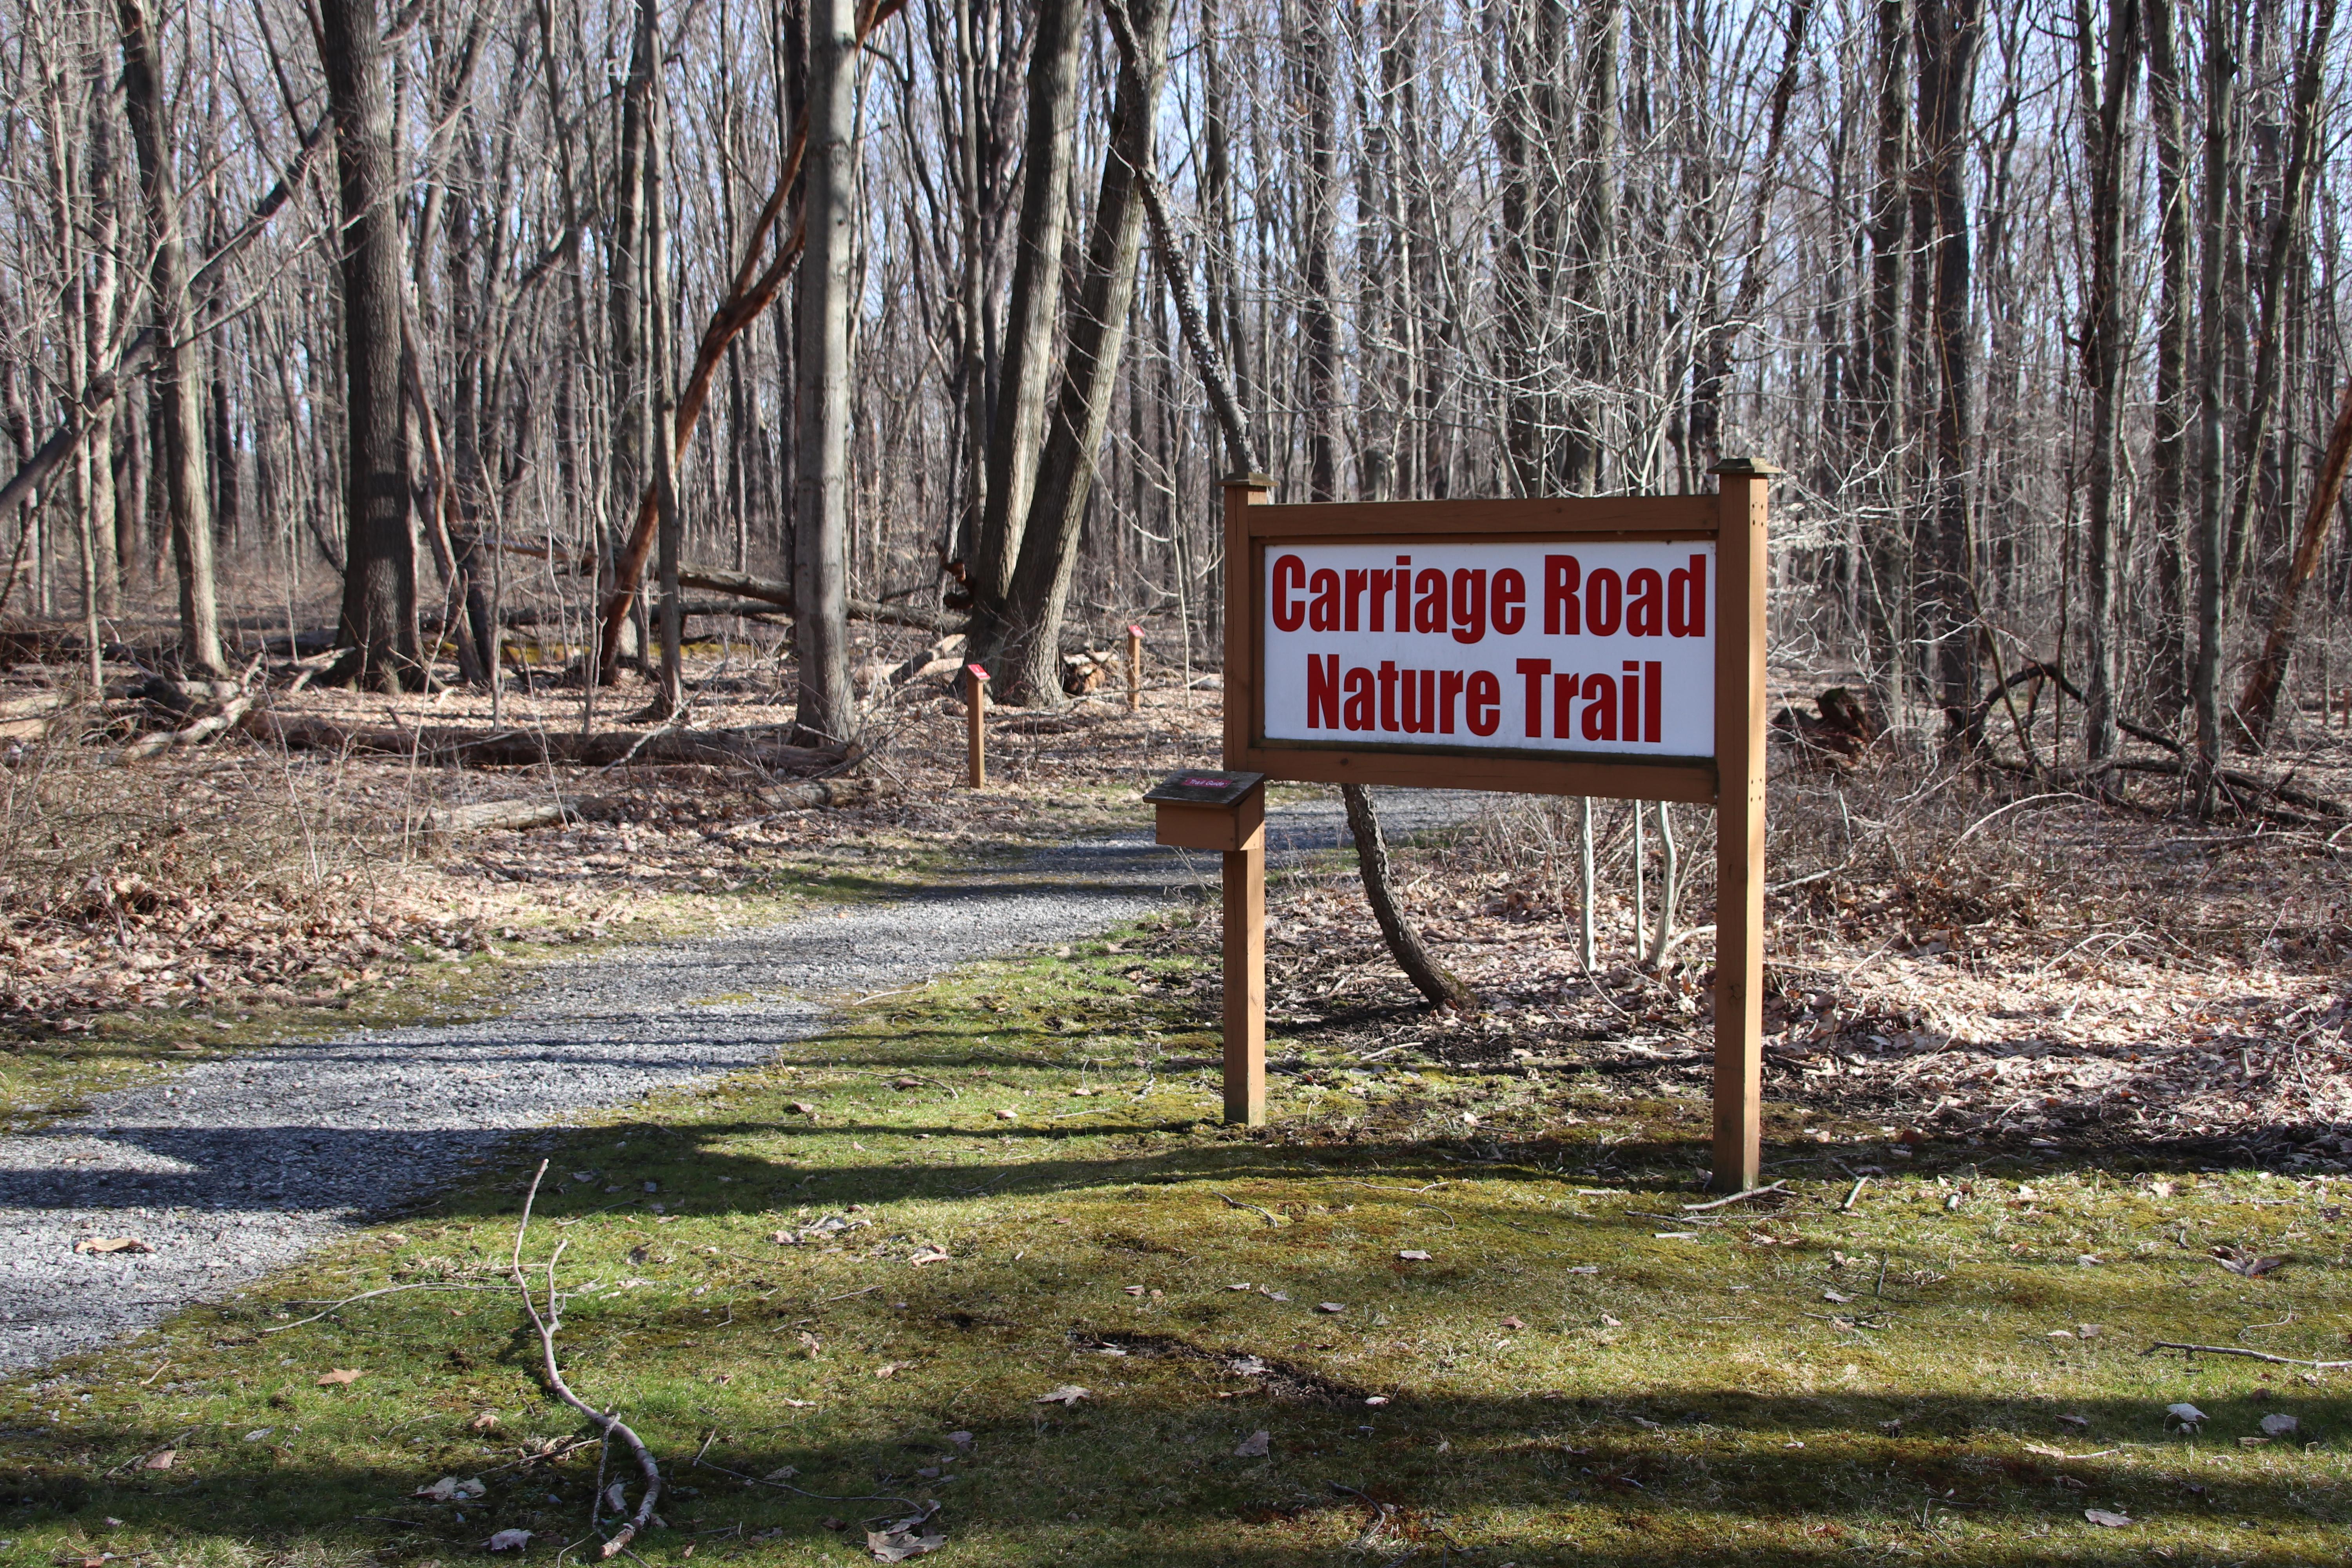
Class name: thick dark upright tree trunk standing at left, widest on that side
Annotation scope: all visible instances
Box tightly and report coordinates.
[320,0,423,689]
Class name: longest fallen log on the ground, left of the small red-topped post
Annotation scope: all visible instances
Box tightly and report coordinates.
[240,712,847,773]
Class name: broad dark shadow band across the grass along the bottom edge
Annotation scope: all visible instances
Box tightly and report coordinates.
[23,1382,2345,1568]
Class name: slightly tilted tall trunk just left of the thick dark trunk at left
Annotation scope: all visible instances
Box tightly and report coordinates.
[115,0,222,677]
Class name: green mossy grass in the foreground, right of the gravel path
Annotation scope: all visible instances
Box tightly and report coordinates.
[0,931,2352,1568]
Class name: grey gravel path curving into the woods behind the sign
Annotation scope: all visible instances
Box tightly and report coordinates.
[0,792,1484,1373]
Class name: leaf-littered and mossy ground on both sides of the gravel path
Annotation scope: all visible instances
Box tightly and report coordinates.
[0,621,2352,1566]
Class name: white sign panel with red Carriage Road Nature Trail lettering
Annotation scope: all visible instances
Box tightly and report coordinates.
[1258,543,1715,757]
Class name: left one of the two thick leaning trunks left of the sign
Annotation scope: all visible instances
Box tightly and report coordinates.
[969,0,1087,663]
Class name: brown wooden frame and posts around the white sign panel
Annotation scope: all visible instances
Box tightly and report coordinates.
[1225,458,1780,1192]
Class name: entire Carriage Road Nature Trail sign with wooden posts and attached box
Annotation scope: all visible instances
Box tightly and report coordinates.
[1145,458,1778,1192]
